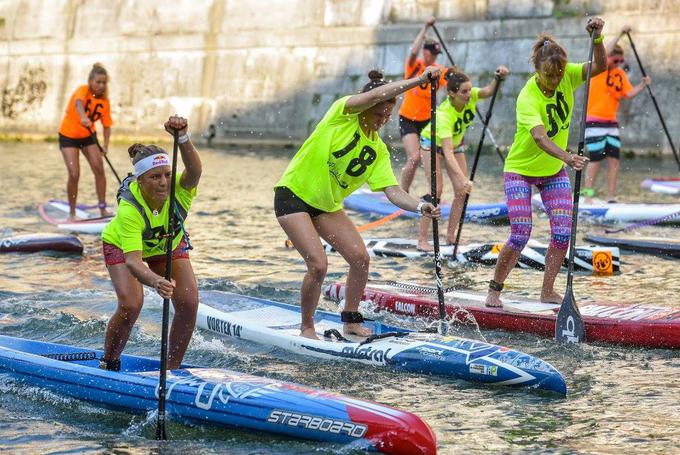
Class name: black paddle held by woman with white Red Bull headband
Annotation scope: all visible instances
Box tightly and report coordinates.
[156,129,179,440]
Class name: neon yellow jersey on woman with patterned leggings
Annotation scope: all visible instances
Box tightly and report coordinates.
[504,63,584,177]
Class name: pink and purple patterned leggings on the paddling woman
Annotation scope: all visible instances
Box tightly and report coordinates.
[503,168,574,251]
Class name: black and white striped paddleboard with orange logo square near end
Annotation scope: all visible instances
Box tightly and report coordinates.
[324,238,621,275]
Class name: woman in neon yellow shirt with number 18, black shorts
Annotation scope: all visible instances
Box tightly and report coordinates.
[274,67,440,338]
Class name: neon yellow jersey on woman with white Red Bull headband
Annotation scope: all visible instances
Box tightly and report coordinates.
[102,173,196,258]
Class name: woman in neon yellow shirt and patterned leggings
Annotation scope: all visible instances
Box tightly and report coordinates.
[486,18,607,307]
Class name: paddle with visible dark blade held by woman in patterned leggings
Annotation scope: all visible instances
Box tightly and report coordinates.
[555,32,595,343]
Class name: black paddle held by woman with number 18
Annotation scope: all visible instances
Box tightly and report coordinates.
[430,76,446,335]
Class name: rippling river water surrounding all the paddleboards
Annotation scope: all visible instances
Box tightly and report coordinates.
[0,144,680,454]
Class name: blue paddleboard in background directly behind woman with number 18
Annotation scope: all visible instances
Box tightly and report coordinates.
[344,189,508,223]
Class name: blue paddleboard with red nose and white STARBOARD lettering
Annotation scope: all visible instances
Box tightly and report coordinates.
[0,335,437,455]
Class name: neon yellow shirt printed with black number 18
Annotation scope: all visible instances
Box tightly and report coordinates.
[274,96,398,212]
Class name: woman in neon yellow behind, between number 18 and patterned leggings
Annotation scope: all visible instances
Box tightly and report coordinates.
[418,65,509,251]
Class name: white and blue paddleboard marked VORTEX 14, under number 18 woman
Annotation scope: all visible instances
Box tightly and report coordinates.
[196,291,567,395]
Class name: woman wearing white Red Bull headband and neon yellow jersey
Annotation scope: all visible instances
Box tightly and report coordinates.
[100,117,202,371]
